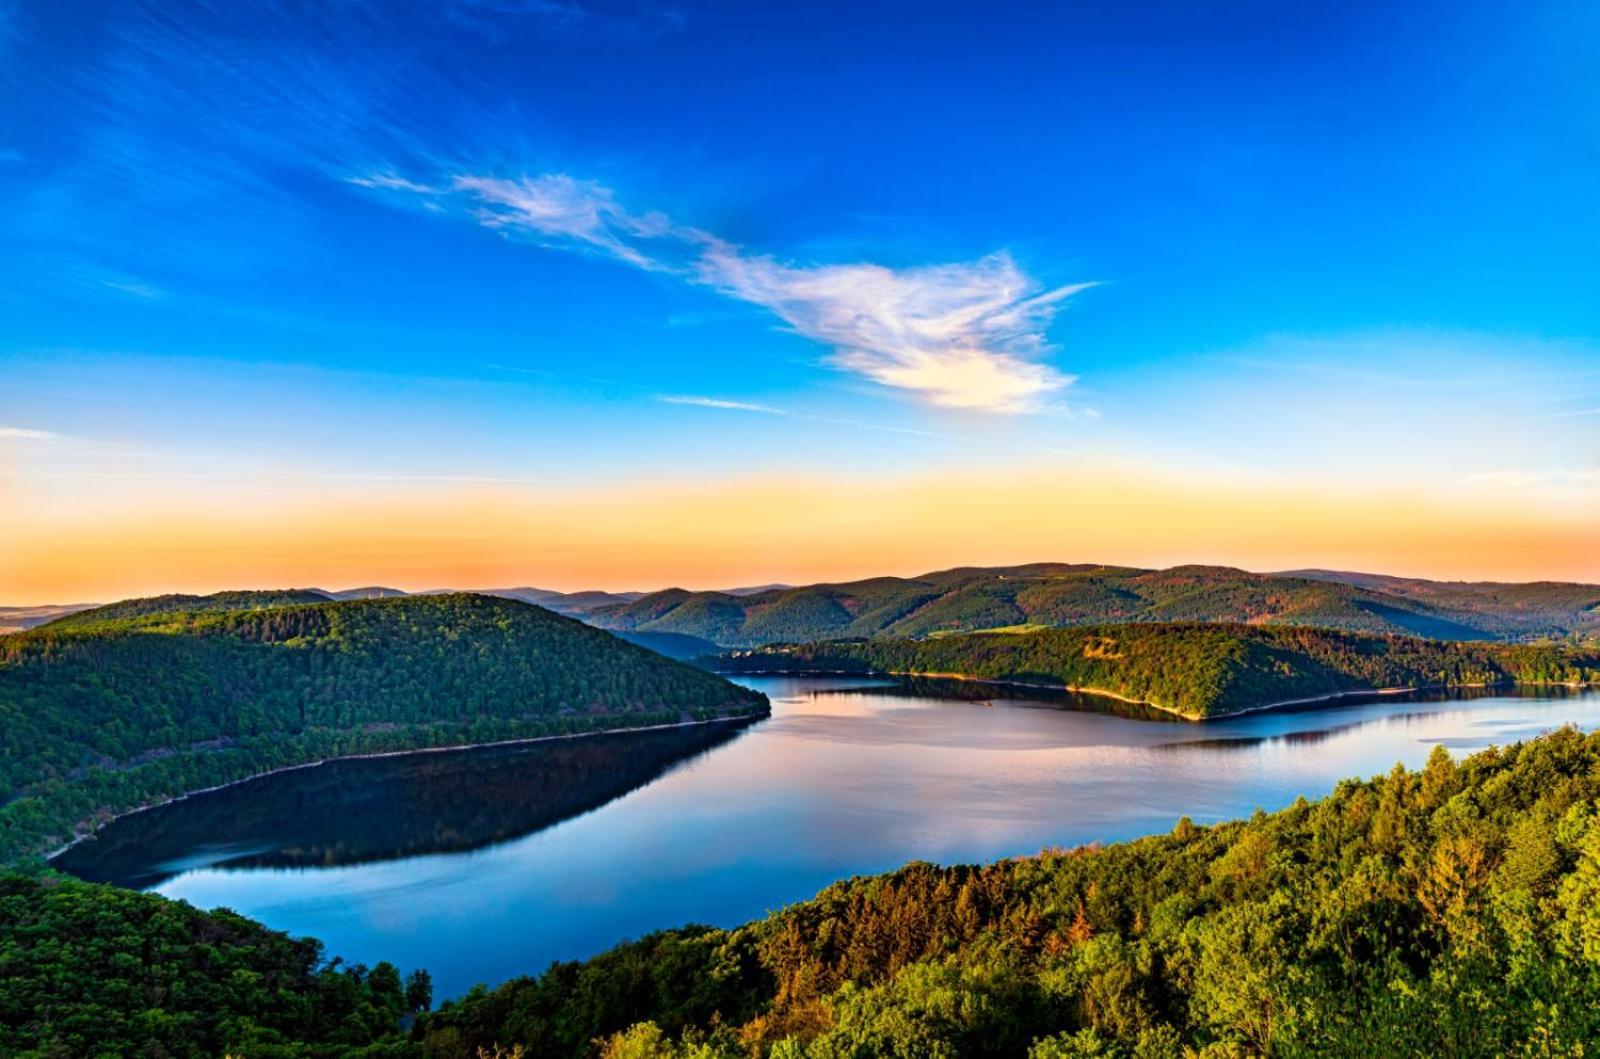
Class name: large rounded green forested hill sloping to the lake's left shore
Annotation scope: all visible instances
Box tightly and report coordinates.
[0,595,768,862]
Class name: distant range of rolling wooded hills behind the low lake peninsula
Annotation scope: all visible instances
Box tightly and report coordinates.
[584,563,1600,646]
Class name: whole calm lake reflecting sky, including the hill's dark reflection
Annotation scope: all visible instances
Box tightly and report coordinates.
[50,678,1600,995]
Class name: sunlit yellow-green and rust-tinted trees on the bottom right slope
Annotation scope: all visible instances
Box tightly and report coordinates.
[418,731,1600,1059]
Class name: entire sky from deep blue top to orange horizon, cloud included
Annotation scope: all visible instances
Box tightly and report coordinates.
[0,0,1600,605]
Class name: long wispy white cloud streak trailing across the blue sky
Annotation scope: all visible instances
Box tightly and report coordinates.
[361,173,1090,414]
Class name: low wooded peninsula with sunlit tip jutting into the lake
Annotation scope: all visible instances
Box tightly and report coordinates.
[715,622,1600,720]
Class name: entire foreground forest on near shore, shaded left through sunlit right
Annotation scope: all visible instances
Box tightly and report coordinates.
[9,731,1600,1059]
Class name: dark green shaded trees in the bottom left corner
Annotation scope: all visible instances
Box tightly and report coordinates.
[0,875,419,1059]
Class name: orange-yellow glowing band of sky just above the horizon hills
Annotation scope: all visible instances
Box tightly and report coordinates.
[0,470,1600,605]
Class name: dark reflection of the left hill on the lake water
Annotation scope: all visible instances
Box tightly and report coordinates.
[53,721,749,889]
